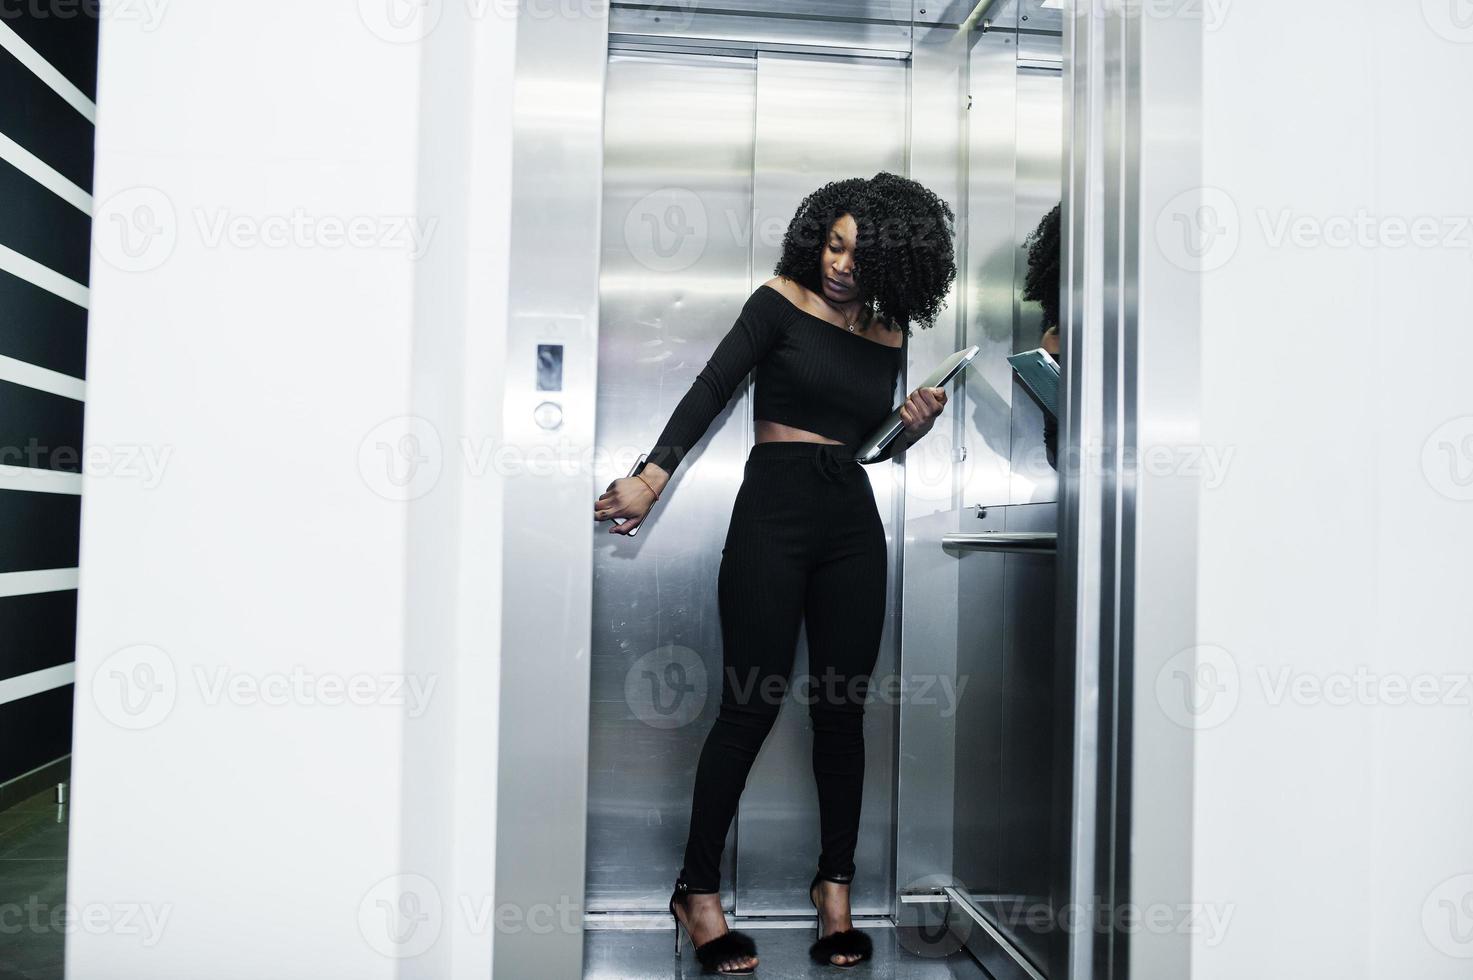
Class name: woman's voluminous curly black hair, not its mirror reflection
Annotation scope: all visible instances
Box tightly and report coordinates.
[773,171,956,335]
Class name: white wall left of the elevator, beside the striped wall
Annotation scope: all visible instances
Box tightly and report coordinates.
[68,0,514,980]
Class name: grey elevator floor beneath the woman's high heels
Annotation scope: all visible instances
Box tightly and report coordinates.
[583,920,990,980]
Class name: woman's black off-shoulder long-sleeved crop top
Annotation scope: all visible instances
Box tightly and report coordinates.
[647,284,904,475]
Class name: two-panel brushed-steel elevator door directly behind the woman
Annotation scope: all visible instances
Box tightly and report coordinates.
[586,50,907,914]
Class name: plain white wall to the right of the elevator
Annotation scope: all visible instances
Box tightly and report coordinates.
[1160,0,1473,980]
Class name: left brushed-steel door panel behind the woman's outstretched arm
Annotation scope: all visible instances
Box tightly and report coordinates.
[588,53,757,912]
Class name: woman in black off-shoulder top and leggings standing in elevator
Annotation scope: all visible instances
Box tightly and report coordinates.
[594,172,956,974]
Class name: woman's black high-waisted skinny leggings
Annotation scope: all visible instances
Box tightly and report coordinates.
[682,442,887,892]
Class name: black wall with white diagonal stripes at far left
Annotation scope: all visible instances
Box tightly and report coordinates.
[0,7,97,784]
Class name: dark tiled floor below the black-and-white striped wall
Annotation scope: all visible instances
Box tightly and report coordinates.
[0,788,69,980]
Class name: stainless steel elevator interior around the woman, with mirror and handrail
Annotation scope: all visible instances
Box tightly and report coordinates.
[585,0,1072,979]
